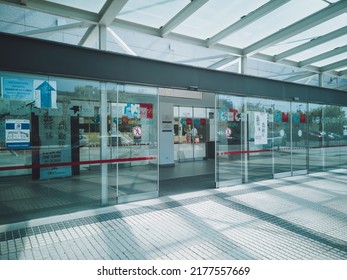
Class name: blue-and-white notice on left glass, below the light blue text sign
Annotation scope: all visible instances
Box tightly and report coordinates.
[5,119,30,150]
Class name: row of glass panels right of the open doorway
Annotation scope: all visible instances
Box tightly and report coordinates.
[216,94,347,186]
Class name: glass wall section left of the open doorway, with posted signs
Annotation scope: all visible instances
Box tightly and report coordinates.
[0,72,158,224]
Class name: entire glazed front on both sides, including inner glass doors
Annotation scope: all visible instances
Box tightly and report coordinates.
[0,72,347,224]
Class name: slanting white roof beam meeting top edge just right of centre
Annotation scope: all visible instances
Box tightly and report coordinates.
[160,0,208,37]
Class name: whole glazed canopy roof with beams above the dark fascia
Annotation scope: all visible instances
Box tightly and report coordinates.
[0,0,347,87]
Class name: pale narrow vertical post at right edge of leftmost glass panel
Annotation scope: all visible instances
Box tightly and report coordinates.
[99,83,108,205]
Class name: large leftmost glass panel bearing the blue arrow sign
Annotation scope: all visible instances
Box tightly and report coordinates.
[0,73,100,224]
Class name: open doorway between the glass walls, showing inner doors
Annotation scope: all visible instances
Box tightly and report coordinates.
[159,89,215,196]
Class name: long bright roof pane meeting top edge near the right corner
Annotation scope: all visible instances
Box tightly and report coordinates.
[220,0,328,48]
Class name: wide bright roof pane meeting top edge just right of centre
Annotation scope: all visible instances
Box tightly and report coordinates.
[173,0,267,40]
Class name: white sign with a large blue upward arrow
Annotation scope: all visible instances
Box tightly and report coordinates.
[34,80,57,109]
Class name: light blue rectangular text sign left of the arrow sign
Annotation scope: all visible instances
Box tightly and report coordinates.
[1,77,34,101]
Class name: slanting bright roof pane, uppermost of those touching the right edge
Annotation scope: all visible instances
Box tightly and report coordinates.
[262,13,347,55]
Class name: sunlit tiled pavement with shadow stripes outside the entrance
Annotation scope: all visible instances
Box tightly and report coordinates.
[0,169,347,260]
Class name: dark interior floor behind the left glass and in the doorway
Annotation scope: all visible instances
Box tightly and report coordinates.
[0,160,215,225]
